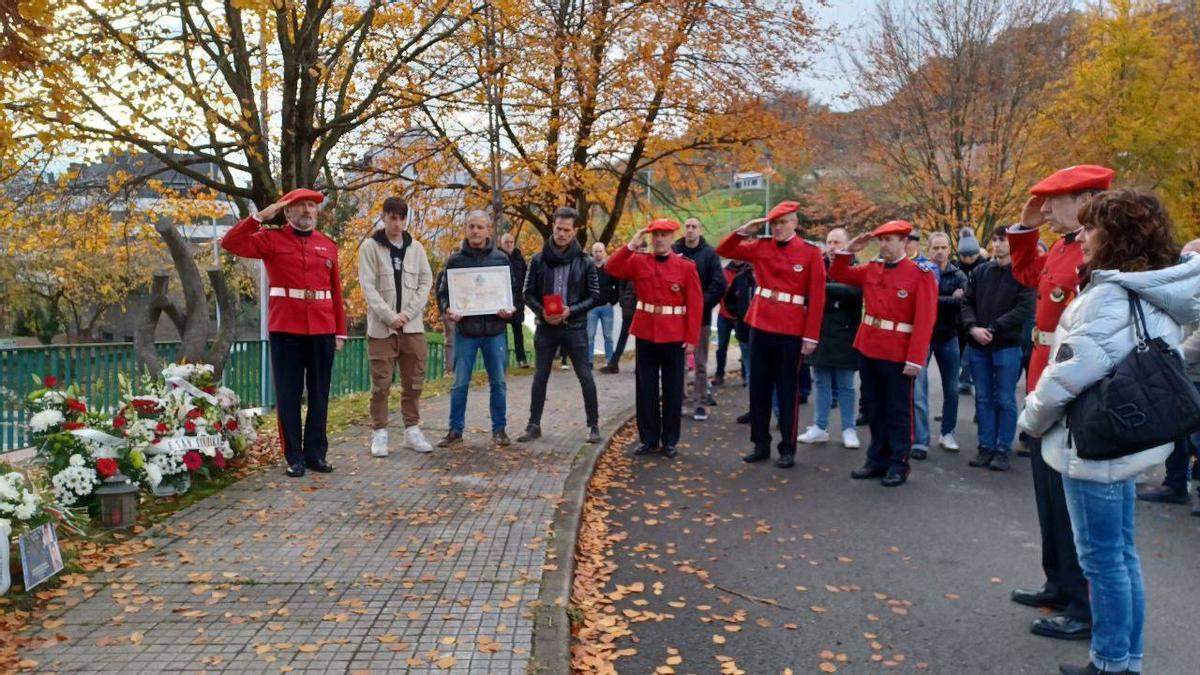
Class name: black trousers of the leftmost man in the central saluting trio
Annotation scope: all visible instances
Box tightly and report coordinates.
[635,340,686,447]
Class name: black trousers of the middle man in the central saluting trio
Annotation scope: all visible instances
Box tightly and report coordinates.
[750,329,804,456]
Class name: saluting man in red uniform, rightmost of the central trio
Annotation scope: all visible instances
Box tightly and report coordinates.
[829,220,937,488]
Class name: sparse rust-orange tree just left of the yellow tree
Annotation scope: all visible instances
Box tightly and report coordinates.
[848,0,1069,241]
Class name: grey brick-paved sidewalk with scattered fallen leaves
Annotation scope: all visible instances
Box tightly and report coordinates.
[26,370,634,673]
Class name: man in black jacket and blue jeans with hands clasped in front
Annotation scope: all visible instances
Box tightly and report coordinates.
[962,227,1037,471]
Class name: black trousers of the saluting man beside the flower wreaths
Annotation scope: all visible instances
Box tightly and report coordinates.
[270,333,337,465]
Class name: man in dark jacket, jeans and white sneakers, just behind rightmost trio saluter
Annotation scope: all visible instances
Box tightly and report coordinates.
[912,232,967,459]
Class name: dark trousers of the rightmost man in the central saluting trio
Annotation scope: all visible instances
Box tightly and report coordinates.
[858,357,914,476]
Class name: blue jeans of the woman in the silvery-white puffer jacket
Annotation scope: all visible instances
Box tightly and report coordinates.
[1070,473,1146,673]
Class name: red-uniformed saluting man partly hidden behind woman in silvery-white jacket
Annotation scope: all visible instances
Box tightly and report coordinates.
[1008,165,1115,640]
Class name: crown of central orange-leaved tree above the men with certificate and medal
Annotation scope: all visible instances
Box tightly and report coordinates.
[420,0,815,243]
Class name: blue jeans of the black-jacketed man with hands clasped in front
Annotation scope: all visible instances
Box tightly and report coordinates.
[967,347,1021,454]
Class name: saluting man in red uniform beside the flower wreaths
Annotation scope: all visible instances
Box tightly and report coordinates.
[221,189,346,478]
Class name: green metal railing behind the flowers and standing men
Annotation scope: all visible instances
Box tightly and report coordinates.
[0,333,514,453]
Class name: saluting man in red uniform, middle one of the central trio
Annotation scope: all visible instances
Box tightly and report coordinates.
[716,202,826,468]
